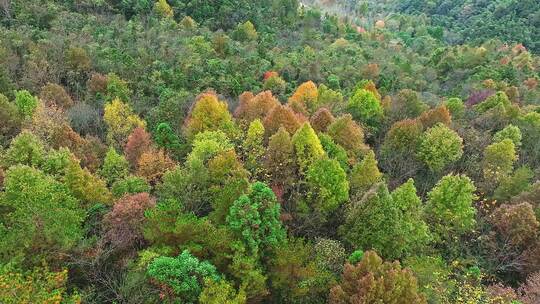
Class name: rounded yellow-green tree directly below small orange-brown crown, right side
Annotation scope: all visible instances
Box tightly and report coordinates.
[418,123,463,172]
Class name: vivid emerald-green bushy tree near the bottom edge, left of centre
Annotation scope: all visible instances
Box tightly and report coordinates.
[147,250,221,303]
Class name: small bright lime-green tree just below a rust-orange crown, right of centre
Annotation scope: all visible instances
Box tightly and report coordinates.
[347,89,384,130]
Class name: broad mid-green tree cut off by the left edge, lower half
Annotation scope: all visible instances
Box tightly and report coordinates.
[0,165,84,262]
